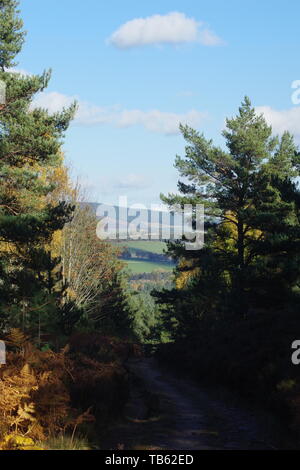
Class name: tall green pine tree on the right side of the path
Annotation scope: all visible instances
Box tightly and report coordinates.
[162,97,297,314]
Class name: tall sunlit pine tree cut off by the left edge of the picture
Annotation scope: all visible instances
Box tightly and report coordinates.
[0,0,76,330]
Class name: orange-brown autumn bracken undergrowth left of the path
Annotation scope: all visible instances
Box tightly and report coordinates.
[0,329,127,450]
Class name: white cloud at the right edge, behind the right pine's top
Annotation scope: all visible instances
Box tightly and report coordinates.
[256,106,300,140]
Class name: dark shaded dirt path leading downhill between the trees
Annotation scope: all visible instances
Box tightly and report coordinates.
[101,358,288,450]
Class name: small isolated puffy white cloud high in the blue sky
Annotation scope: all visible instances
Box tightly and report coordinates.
[108,12,223,49]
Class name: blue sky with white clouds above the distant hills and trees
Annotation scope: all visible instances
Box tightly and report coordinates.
[17,0,300,207]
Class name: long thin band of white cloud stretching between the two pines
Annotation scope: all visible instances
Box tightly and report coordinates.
[32,92,206,135]
